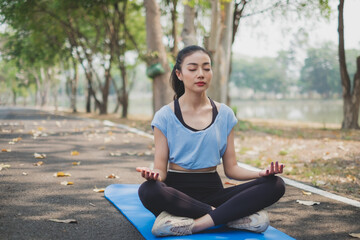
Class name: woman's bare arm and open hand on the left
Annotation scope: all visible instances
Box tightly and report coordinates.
[136,127,169,181]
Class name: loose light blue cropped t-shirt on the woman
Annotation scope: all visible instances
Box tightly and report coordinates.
[151,104,237,169]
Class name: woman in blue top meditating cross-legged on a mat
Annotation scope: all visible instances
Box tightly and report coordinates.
[136,46,285,236]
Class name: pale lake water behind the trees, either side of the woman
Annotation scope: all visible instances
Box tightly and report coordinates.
[54,93,354,124]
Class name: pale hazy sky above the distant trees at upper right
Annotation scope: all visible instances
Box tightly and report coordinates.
[233,0,360,57]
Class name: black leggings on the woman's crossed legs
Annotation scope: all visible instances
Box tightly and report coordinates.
[139,172,285,225]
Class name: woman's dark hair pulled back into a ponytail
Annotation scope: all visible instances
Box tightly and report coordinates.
[170,45,211,100]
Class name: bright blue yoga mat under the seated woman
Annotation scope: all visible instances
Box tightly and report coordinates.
[105,184,294,240]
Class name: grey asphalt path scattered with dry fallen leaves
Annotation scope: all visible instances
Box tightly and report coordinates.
[0,107,360,240]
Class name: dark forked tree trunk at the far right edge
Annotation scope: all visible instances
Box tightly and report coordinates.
[338,0,360,129]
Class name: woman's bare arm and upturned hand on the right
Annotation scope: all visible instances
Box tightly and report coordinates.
[222,130,284,180]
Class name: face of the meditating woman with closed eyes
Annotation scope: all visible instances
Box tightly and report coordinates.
[176,51,212,92]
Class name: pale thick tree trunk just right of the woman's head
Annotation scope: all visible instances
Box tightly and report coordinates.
[208,0,234,103]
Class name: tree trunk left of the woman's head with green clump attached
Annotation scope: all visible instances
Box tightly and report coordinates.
[144,0,172,113]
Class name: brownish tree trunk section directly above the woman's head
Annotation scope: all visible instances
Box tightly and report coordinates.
[181,4,197,47]
